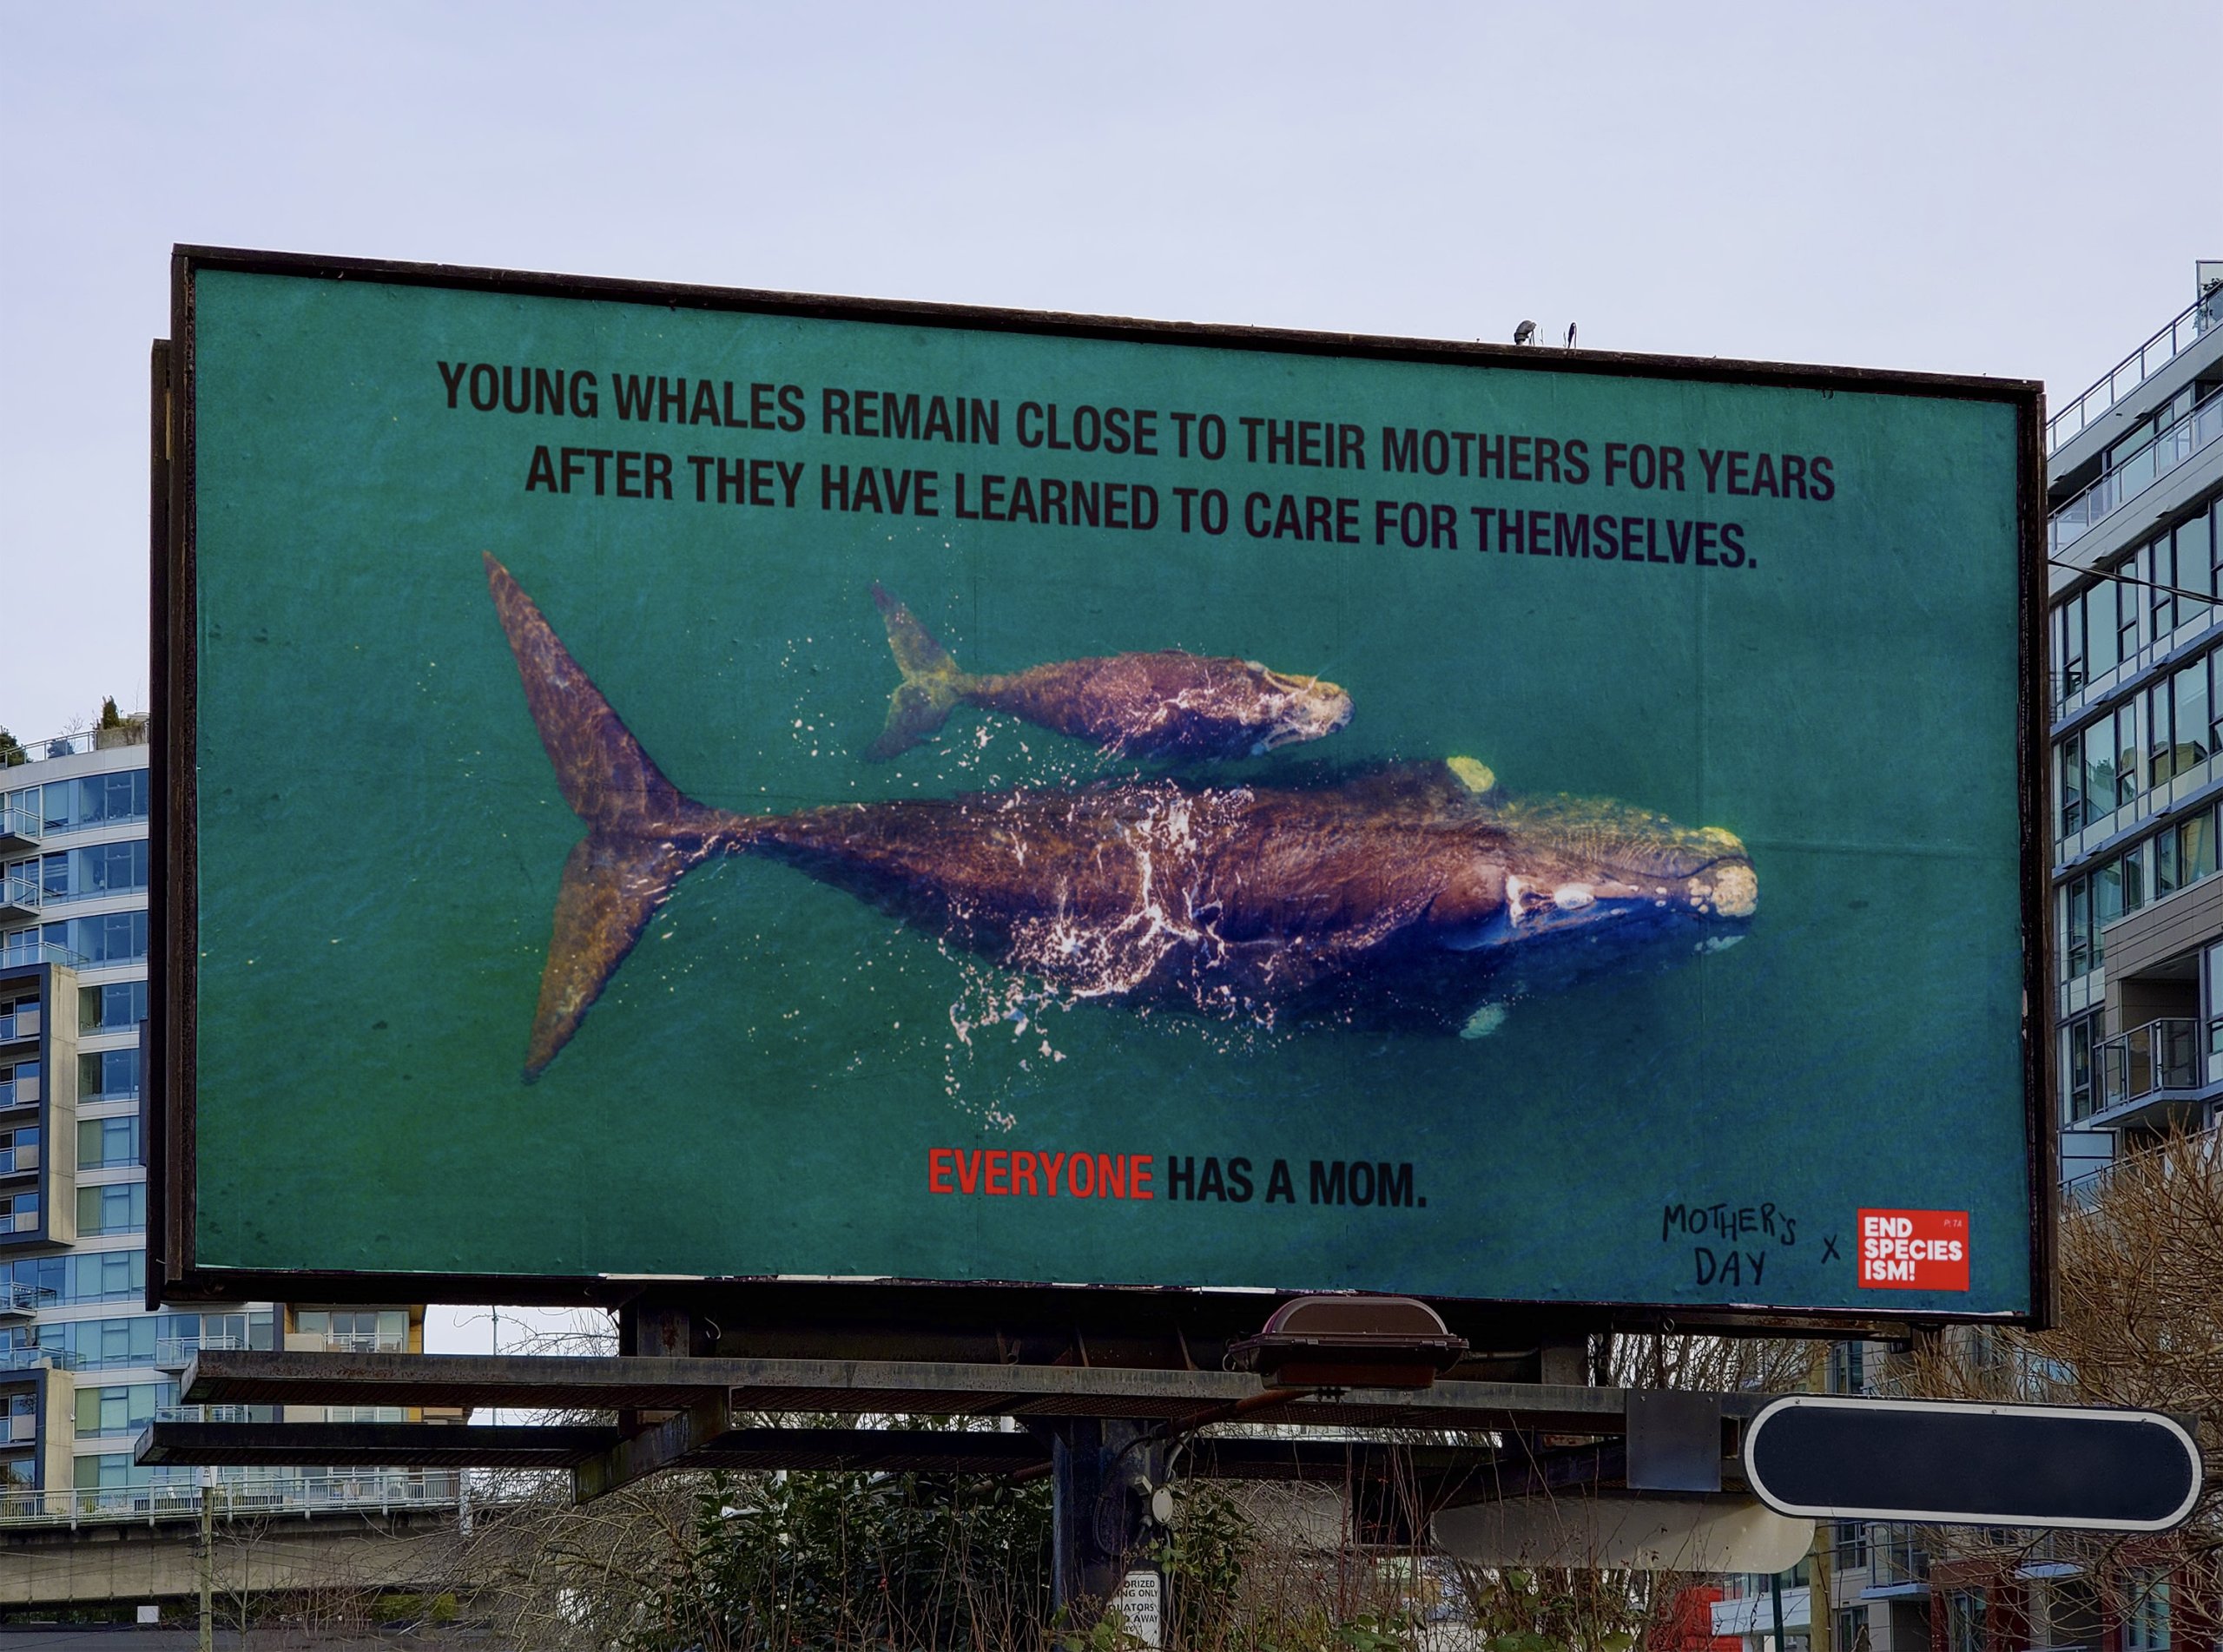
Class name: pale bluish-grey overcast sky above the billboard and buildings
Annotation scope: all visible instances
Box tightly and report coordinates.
[0,0,2223,1346]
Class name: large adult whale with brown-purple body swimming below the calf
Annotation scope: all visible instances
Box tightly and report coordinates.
[487,554,1758,1081]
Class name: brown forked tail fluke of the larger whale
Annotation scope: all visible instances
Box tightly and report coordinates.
[487,551,722,1083]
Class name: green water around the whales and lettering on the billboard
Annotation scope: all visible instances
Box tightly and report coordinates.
[195,271,2029,1312]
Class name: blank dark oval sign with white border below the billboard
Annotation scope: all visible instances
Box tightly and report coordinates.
[1745,1394,2200,1532]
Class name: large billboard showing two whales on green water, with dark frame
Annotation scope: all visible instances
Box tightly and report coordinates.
[158,251,2048,1319]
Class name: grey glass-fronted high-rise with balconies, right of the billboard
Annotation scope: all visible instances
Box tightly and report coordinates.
[2045,262,2223,1188]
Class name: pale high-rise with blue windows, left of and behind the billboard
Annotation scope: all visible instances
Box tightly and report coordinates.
[0,716,456,1523]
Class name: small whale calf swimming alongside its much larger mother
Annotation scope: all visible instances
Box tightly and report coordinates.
[865,585,1351,758]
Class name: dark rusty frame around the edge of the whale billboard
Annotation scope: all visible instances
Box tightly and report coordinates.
[142,245,2056,1336]
